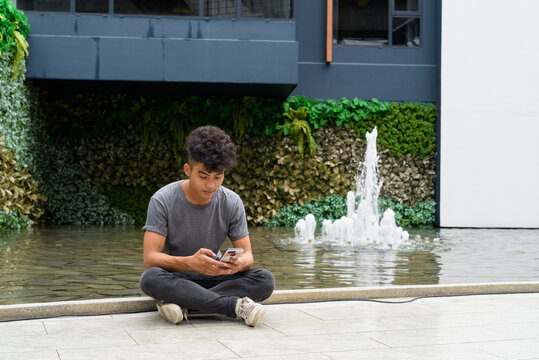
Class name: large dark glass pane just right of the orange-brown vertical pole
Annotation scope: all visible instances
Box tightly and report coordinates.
[336,0,389,46]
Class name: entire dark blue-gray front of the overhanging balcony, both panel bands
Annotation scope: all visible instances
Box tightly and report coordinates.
[23,13,298,88]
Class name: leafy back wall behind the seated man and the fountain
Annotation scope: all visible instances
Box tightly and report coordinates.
[35,93,436,226]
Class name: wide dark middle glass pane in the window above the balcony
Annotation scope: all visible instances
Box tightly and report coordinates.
[114,0,198,16]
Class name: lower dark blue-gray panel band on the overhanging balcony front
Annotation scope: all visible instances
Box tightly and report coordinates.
[27,35,298,85]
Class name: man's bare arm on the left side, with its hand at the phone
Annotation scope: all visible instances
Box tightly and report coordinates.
[142,230,233,275]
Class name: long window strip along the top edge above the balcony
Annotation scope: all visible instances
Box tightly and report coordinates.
[17,0,292,19]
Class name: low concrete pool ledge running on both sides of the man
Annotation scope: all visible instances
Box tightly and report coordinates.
[0,282,539,321]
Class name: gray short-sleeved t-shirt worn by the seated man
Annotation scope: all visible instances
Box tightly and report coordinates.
[142,180,249,256]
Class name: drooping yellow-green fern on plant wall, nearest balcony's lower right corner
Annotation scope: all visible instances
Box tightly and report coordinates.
[277,107,316,156]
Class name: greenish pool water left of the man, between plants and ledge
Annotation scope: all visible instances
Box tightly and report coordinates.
[0,227,143,304]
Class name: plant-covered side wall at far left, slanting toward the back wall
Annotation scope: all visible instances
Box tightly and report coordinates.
[0,0,134,228]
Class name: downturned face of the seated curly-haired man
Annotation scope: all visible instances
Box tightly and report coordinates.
[183,161,225,203]
